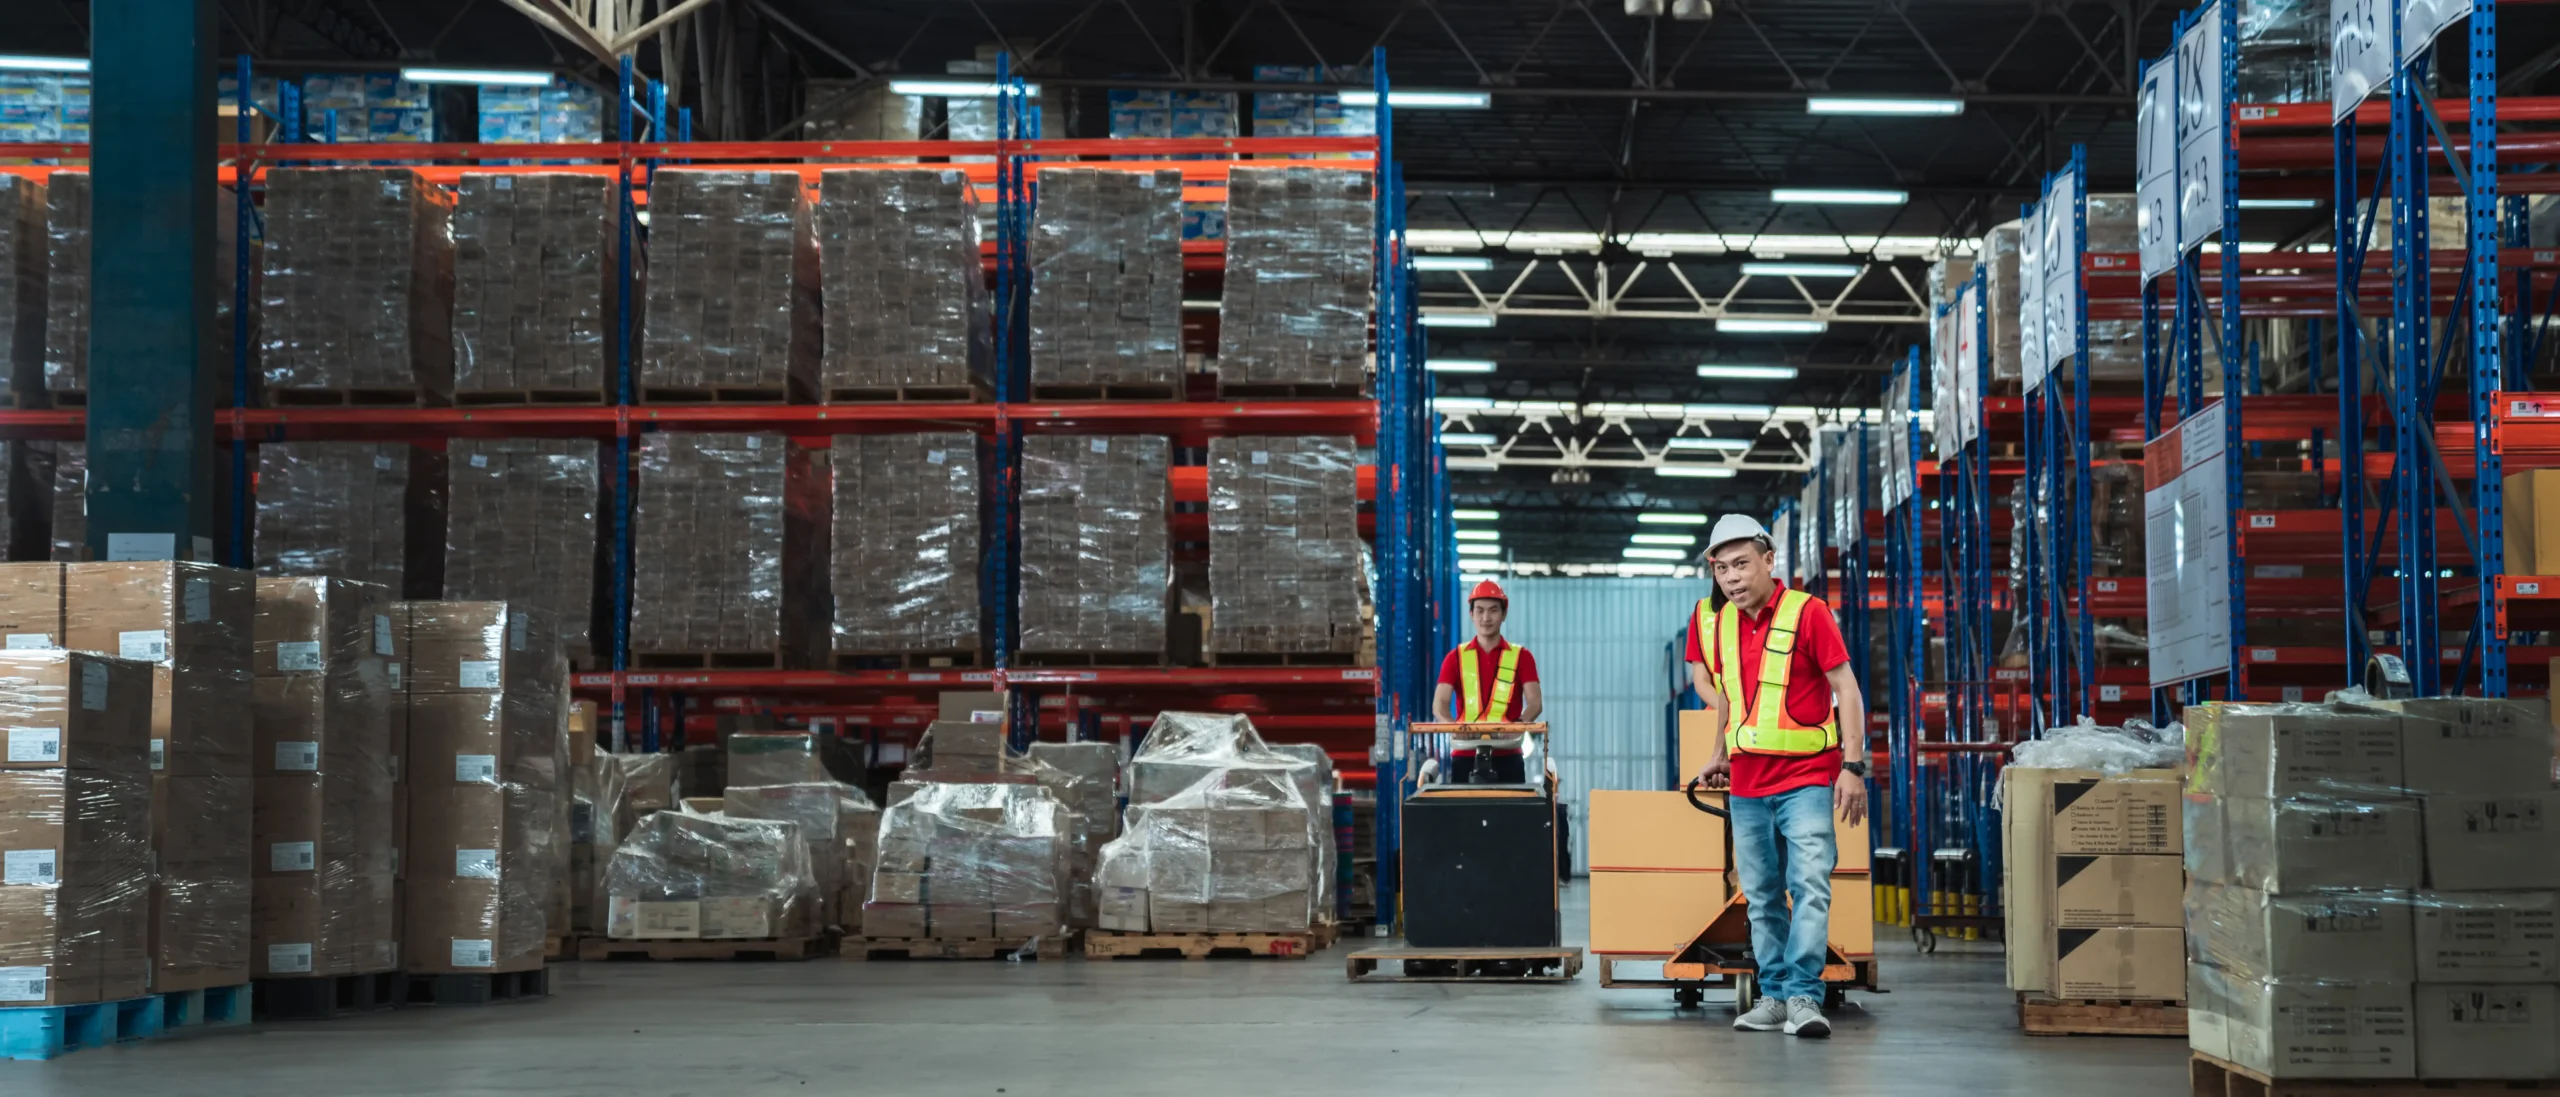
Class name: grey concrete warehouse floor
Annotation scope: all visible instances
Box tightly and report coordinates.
[15,887,2186,1097]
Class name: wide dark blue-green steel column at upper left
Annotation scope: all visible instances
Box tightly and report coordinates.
[87,0,220,560]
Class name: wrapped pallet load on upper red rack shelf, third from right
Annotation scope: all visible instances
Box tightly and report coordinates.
[817,169,993,399]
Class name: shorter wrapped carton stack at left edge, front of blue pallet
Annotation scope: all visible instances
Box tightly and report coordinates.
[0,650,153,1008]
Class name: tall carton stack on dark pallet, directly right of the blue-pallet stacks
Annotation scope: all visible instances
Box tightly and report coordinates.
[248,578,404,979]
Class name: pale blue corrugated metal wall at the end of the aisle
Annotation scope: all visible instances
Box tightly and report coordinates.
[1503,578,1708,875]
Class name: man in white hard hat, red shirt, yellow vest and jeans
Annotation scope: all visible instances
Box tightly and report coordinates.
[1690,514,1866,1036]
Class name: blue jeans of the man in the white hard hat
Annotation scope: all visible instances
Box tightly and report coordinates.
[1725,785,1841,1002]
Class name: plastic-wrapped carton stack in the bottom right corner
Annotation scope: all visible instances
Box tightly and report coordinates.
[2184,698,2560,1079]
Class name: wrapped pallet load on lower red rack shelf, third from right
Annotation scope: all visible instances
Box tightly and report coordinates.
[829,435,983,657]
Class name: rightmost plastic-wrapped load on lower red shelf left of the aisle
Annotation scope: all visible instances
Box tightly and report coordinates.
[1208,437,1367,655]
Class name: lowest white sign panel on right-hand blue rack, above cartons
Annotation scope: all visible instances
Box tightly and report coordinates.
[2143,399,2232,688]
